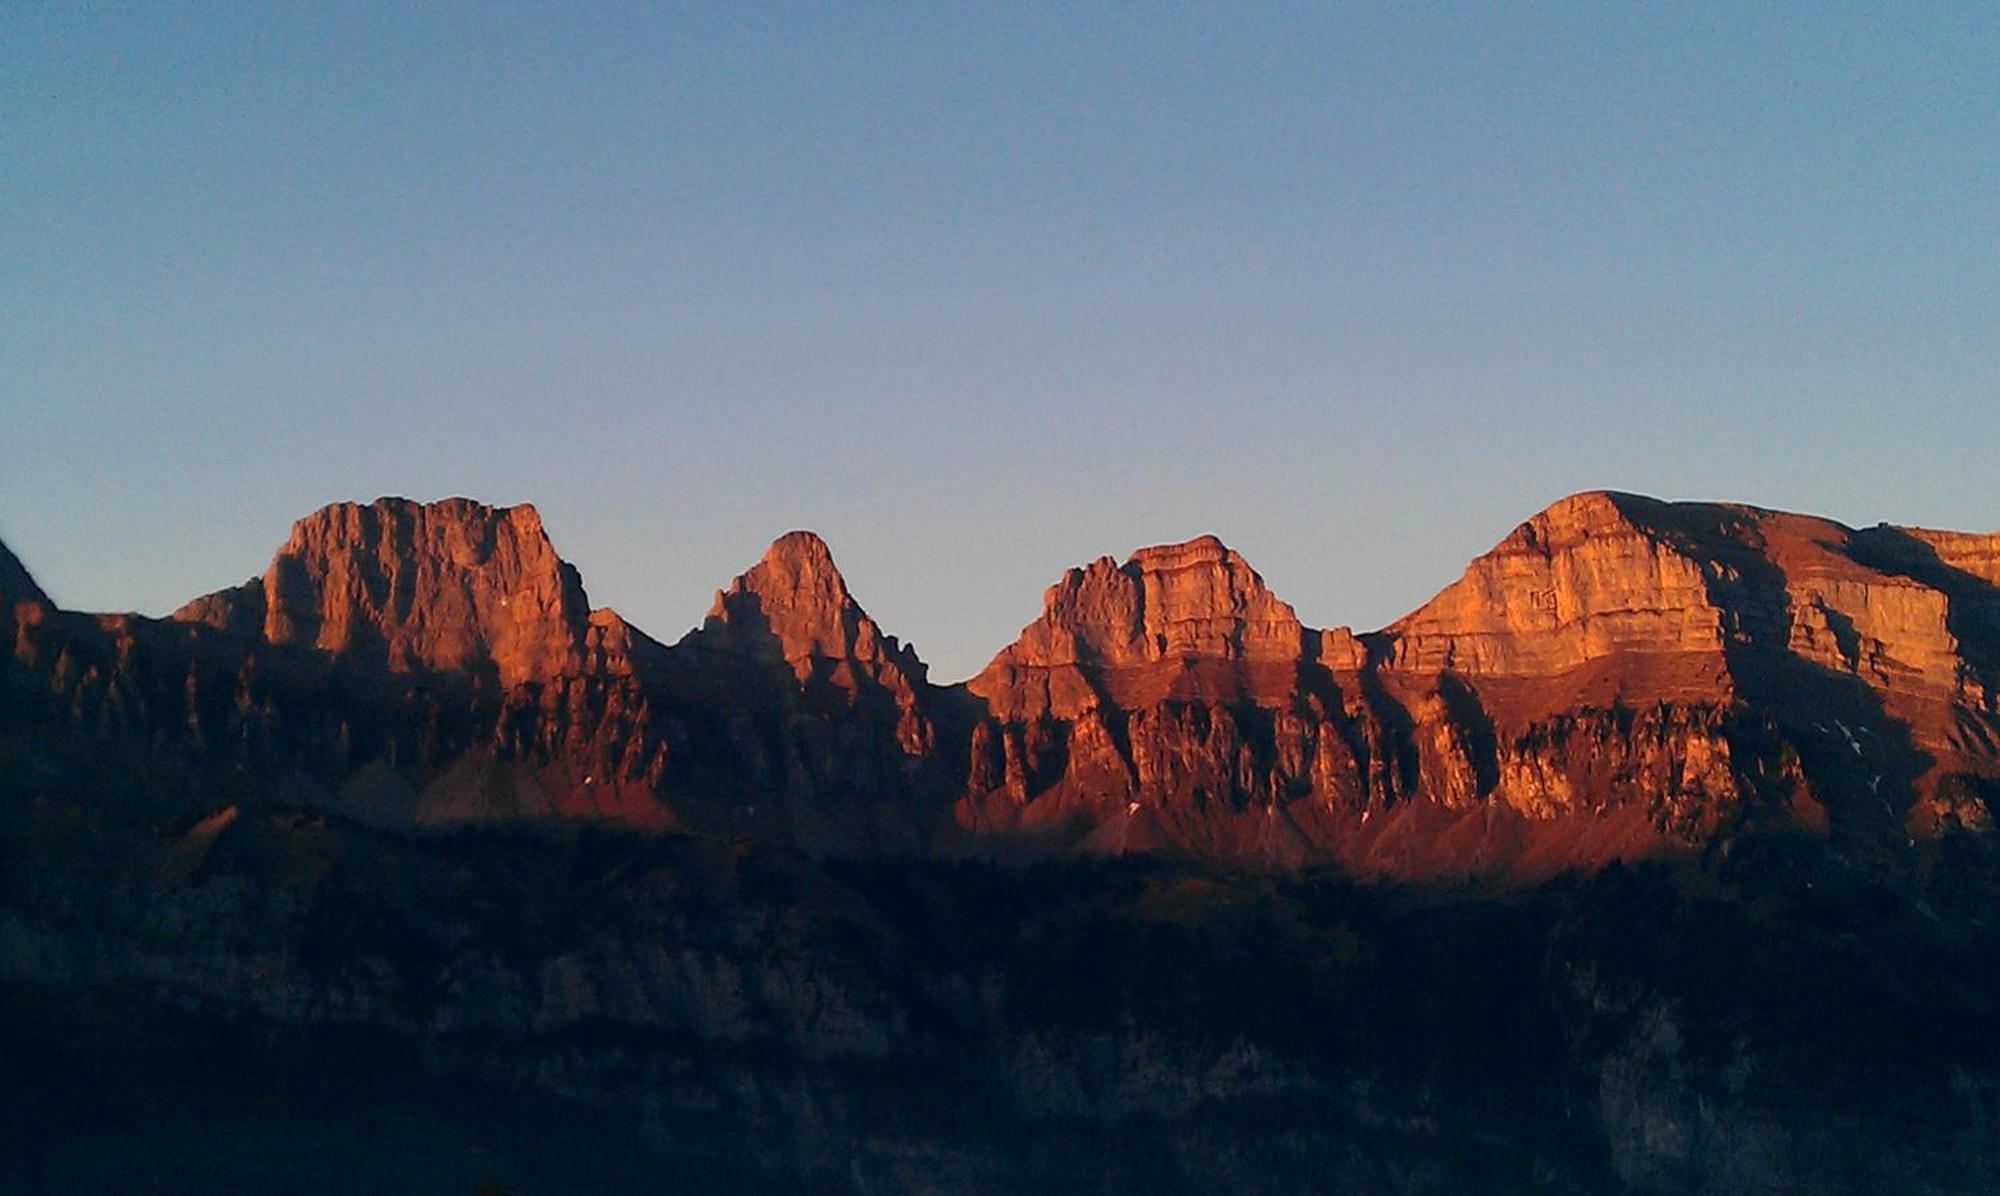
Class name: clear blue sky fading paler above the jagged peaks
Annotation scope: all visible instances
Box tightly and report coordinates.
[0,2,2000,680]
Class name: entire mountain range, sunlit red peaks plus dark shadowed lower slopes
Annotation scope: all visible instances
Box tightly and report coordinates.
[0,492,2000,1194]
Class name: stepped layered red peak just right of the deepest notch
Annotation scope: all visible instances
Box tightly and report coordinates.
[956,536,1368,862]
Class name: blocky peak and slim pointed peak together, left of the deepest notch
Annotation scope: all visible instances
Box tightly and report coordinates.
[10,500,950,852]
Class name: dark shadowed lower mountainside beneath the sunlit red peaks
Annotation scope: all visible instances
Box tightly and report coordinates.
[11,720,2000,1194]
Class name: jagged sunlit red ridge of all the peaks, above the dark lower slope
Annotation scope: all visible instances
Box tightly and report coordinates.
[0,492,2000,880]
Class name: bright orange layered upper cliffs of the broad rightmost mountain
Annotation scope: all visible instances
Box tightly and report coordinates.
[1388,494,1994,708]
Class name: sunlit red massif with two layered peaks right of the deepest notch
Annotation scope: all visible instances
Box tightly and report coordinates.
[958,492,2000,874]
